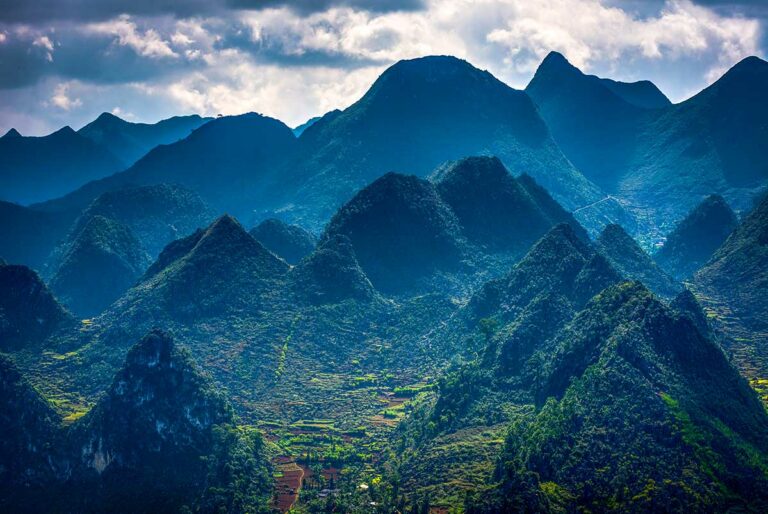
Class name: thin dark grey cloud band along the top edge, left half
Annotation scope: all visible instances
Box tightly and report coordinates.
[0,0,423,25]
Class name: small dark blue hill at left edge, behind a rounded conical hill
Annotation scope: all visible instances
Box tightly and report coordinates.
[0,201,77,271]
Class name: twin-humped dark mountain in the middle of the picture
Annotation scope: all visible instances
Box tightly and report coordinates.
[321,157,589,296]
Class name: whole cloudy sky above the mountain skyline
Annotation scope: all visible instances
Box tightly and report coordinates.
[0,0,768,135]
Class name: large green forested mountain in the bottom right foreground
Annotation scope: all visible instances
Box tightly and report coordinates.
[481,283,768,512]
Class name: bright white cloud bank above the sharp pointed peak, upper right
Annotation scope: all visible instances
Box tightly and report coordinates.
[487,0,759,71]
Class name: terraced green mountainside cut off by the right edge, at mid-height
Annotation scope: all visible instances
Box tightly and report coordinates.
[691,192,768,379]
